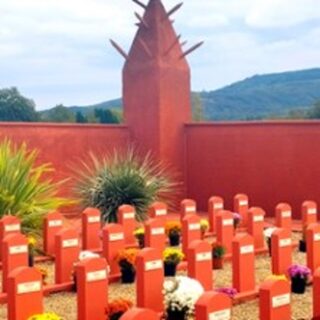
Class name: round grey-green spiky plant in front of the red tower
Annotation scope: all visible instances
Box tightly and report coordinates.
[76,149,179,222]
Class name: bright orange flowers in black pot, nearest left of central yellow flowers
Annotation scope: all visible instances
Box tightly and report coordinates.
[117,248,138,283]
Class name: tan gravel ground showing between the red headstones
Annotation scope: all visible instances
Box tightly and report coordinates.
[0,234,312,320]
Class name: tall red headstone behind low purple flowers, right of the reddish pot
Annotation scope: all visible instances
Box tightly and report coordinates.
[232,235,256,292]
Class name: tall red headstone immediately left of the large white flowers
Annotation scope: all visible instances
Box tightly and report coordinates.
[136,248,164,312]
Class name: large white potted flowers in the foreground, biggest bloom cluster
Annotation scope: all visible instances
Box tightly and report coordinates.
[164,276,204,320]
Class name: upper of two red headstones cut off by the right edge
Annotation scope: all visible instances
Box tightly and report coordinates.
[306,223,320,272]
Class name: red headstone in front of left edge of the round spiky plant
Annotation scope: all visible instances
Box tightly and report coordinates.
[82,208,101,250]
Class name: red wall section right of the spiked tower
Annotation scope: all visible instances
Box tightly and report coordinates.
[186,121,320,217]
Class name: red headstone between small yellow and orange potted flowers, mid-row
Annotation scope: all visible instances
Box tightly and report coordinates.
[145,218,166,252]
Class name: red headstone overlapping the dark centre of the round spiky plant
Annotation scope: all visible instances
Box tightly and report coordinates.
[118,205,136,245]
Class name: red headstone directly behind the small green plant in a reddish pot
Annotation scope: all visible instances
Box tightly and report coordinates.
[216,210,234,253]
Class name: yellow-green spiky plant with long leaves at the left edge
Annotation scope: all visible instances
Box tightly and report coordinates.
[0,139,70,234]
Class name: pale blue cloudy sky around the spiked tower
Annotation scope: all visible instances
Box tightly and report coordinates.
[0,0,320,110]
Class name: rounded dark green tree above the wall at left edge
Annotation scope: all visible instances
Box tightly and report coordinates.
[0,87,38,122]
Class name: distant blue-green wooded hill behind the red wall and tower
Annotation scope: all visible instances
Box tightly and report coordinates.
[44,68,320,120]
